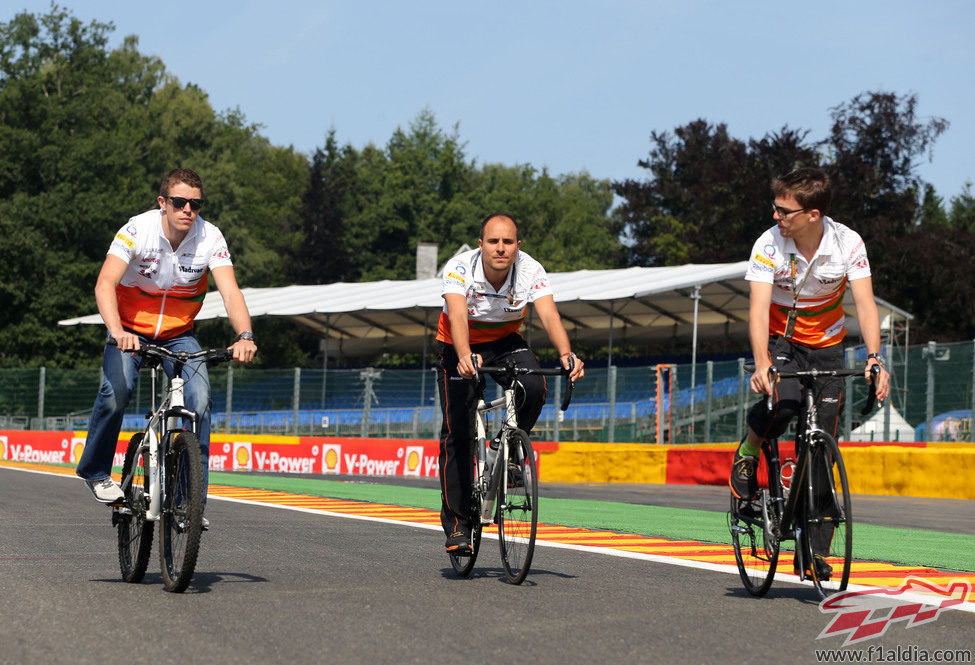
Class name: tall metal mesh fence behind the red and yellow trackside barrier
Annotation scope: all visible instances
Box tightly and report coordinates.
[0,342,975,443]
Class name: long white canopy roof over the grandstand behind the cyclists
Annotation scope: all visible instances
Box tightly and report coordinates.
[58,261,911,356]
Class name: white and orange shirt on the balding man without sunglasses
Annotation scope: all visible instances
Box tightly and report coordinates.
[437,249,552,344]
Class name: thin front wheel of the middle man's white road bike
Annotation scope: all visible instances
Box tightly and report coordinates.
[497,429,538,584]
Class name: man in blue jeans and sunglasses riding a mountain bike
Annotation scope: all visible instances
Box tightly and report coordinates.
[76,168,257,510]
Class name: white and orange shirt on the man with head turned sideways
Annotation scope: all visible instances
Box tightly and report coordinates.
[745,217,870,348]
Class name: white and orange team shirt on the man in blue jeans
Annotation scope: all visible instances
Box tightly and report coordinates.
[108,210,233,339]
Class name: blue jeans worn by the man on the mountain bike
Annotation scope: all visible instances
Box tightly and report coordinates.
[75,333,210,496]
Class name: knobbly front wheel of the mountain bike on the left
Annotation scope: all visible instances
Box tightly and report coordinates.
[159,432,204,593]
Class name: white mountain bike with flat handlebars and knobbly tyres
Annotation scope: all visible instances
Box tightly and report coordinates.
[112,344,233,593]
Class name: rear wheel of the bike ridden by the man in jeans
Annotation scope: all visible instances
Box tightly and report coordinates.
[113,434,153,584]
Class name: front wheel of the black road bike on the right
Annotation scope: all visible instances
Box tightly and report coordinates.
[805,432,853,598]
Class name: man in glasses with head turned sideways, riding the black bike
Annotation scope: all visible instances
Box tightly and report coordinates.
[729,168,890,579]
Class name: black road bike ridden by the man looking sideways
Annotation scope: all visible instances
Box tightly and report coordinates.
[728,365,880,598]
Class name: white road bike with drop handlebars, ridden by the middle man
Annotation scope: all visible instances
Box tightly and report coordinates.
[449,357,575,584]
